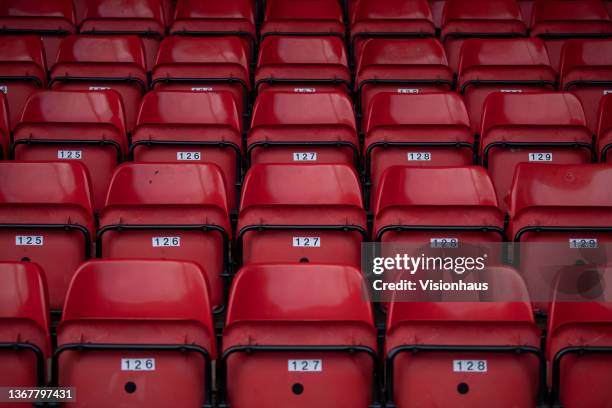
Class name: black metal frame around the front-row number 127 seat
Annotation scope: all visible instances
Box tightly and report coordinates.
[218,345,381,408]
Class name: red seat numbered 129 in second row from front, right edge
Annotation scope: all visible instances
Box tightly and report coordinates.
[508,163,612,312]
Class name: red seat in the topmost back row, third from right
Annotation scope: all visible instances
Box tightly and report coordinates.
[351,0,436,61]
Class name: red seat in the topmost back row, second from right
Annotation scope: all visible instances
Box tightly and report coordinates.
[440,0,527,72]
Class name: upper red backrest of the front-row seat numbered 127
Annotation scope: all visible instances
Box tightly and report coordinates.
[223,264,375,349]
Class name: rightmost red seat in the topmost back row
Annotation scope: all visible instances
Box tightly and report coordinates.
[531,0,612,70]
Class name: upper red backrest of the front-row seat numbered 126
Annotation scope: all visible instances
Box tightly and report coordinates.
[58,260,215,358]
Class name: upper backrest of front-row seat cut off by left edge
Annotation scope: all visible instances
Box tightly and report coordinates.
[0,262,51,356]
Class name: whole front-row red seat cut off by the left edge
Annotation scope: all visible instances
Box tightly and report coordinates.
[0,262,51,390]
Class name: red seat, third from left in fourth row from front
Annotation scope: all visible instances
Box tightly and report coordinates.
[151,36,251,122]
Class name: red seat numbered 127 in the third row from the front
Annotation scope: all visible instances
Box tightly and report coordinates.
[247,89,359,166]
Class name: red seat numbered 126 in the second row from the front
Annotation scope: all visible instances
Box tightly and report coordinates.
[96,163,231,308]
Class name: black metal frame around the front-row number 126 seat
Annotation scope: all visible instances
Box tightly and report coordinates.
[51,343,213,408]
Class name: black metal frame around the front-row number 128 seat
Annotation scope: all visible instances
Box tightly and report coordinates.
[385,345,547,408]
